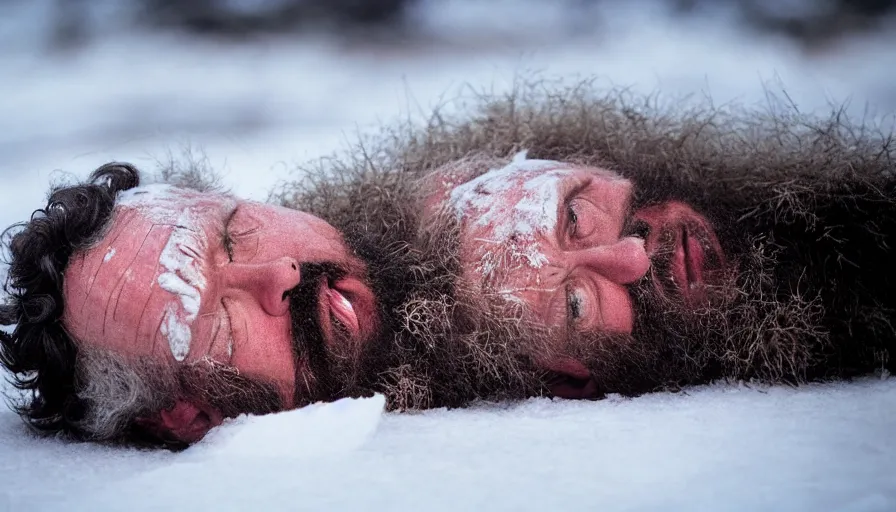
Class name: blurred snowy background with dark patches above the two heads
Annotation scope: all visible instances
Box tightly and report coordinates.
[0,0,896,241]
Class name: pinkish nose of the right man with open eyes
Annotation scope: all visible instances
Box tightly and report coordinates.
[575,237,650,284]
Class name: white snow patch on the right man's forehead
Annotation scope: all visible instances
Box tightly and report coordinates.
[449,152,573,277]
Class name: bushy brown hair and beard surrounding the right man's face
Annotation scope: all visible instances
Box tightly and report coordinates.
[280,82,896,400]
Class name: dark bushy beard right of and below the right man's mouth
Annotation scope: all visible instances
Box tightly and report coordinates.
[552,168,896,395]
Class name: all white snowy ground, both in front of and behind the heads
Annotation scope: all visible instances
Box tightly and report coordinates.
[0,0,896,512]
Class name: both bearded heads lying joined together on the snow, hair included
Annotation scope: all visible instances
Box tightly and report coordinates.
[0,82,896,446]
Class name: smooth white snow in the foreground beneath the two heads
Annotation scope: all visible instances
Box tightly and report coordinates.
[0,379,896,512]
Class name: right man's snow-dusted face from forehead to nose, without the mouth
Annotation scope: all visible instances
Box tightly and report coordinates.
[428,156,650,378]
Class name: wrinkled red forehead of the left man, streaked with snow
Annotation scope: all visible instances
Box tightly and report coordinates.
[64,185,236,360]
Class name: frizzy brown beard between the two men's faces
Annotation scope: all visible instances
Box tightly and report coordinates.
[330,218,547,410]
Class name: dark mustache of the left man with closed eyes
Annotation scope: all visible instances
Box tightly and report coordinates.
[287,262,348,406]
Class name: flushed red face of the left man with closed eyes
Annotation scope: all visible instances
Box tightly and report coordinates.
[64,185,377,414]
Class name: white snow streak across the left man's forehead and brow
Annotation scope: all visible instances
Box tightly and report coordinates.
[116,185,223,361]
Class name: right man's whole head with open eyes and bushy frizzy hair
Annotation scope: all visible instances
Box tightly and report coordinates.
[281,84,896,405]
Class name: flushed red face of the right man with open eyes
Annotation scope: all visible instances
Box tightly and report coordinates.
[430,159,724,388]
